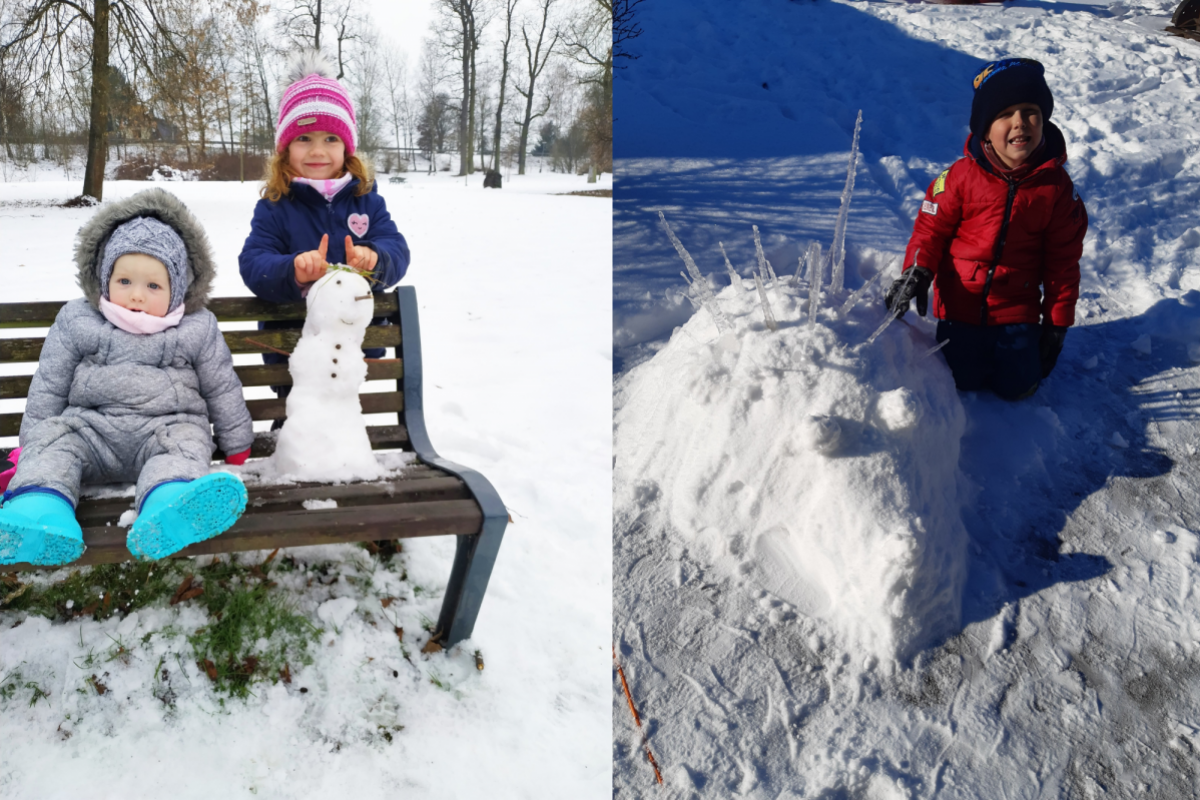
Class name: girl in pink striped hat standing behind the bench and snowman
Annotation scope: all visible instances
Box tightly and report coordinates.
[238,52,409,396]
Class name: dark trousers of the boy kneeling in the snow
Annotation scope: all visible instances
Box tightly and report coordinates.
[937,319,1042,401]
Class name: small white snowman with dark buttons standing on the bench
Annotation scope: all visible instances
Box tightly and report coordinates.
[275,266,383,481]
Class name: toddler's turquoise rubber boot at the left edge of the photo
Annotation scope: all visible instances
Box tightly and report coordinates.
[0,492,84,566]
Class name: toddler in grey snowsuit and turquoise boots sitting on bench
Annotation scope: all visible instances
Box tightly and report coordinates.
[0,190,254,564]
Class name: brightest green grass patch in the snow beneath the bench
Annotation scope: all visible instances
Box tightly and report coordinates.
[187,576,322,697]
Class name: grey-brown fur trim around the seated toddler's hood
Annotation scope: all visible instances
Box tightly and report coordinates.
[76,188,217,314]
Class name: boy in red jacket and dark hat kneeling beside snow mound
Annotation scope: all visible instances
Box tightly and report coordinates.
[886,59,1087,399]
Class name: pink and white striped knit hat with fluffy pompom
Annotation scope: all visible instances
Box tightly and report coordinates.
[275,50,359,156]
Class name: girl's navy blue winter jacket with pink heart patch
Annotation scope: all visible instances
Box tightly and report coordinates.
[238,178,408,302]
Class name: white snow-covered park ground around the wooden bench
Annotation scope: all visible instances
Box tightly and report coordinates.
[0,168,612,799]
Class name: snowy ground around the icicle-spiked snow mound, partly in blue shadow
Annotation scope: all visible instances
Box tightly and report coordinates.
[613,0,1200,800]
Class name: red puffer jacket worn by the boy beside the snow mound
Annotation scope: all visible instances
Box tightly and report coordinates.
[904,122,1087,325]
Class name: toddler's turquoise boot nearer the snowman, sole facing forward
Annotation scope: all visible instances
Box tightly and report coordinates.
[125,473,246,560]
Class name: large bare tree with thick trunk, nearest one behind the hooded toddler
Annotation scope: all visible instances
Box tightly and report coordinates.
[0,0,174,199]
